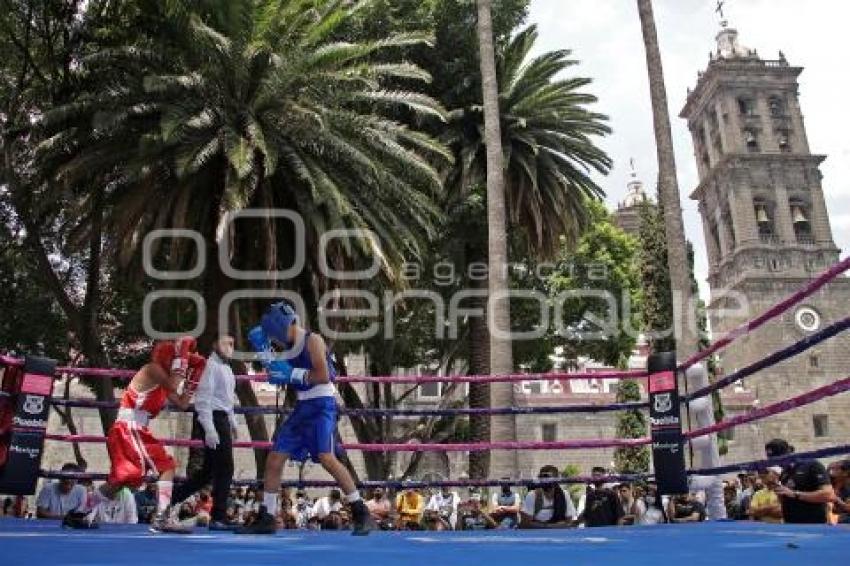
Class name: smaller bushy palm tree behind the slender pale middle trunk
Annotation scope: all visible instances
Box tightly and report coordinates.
[460,18,611,477]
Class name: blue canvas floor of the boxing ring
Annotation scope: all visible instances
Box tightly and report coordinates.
[0,520,850,566]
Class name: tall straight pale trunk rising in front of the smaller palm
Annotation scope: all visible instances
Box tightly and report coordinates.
[478,0,518,475]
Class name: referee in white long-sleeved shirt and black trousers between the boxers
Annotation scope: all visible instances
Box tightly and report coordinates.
[172,334,237,530]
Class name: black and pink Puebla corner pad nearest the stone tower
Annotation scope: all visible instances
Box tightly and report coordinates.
[647,352,688,495]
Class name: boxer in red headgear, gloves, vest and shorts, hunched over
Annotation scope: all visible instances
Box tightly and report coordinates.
[101,337,206,533]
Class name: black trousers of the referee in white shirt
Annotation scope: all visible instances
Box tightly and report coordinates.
[171,411,233,521]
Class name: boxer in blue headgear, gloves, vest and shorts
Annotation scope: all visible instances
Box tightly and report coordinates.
[237,302,372,535]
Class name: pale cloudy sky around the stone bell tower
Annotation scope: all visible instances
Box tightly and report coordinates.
[529,0,850,297]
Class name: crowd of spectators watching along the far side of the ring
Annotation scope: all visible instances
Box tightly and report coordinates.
[6,450,850,531]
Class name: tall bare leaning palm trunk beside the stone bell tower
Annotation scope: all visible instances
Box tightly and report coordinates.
[637,0,697,361]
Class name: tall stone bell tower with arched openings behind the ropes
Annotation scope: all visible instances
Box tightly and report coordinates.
[681,22,850,461]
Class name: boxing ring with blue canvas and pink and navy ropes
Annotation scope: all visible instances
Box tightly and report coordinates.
[0,258,850,566]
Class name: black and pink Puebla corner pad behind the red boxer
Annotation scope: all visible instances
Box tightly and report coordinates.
[0,356,56,495]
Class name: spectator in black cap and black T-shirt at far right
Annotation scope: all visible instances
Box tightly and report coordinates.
[764,438,835,524]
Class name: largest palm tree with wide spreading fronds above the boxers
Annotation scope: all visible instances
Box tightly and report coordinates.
[42,0,451,469]
